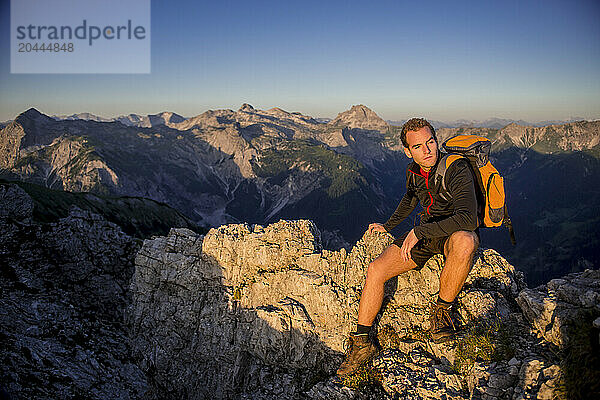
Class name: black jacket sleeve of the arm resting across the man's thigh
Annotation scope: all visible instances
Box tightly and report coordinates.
[415,160,478,239]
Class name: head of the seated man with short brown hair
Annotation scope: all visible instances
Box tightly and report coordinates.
[400,118,438,171]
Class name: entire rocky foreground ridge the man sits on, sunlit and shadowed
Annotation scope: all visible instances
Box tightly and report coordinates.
[0,184,600,399]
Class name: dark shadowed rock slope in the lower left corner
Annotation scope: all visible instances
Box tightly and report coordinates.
[0,205,149,399]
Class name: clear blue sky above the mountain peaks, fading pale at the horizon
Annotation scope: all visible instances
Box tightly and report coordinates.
[0,0,600,121]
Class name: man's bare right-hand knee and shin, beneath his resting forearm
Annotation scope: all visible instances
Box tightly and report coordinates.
[440,231,479,302]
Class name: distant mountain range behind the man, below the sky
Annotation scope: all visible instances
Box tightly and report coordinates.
[0,104,600,283]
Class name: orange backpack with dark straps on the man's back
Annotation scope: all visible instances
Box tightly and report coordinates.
[436,135,516,244]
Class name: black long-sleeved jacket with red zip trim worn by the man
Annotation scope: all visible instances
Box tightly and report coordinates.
[383,153,479,239]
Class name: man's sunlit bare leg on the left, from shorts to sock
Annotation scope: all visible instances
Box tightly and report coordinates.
[358,244,417,326]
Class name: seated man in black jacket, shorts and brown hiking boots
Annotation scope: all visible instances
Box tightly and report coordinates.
[337,118,479,377]
